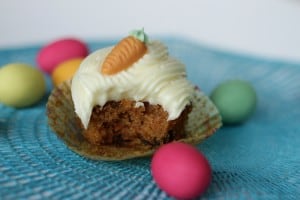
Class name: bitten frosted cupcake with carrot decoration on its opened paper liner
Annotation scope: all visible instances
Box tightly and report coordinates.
[47,30,221,160]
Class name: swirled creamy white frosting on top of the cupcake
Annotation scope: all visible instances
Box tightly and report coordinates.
[71,41,194,128]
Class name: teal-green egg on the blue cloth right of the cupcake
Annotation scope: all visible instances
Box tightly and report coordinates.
[211,80,256,124]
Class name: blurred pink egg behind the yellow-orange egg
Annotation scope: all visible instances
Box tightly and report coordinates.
[36,38,89,74]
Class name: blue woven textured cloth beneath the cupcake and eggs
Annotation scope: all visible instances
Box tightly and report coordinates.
[0,38,300,199]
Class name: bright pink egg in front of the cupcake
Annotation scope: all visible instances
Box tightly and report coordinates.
[151,142,212,199]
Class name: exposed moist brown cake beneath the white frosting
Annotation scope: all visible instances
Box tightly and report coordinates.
[83,100,191,147]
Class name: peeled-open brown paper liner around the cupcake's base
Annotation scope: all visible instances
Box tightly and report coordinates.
[47,81,222,160]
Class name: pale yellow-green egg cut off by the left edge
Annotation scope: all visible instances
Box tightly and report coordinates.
[0,63,46,108]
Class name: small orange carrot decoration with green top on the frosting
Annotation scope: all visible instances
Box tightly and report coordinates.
[101,30,147,75]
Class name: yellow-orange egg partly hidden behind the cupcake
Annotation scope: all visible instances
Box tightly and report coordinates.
[52,58,83,86]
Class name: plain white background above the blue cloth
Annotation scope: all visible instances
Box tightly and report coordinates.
[0,0,300,62]
